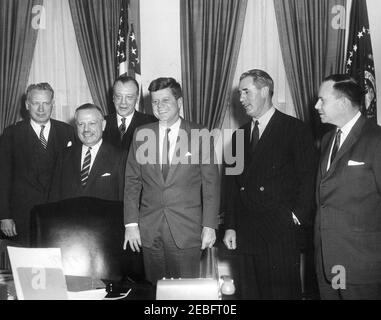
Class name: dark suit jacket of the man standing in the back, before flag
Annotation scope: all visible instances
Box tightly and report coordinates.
[103,111,157,151]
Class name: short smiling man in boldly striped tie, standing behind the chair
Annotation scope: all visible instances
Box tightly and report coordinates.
[49,104,126,201]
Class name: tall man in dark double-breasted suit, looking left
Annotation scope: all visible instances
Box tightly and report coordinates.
[224,69,315,299]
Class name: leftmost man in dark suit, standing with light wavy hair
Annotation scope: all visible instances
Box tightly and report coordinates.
[0,83,75,245]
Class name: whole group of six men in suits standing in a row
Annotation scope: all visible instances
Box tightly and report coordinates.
[0,69,381,299]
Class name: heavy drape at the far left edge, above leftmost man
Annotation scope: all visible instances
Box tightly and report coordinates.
[0,0,42,134]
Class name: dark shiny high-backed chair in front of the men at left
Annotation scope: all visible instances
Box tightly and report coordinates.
[31,197,144,282]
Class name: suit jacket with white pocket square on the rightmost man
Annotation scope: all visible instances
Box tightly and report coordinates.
[315,117,381,284]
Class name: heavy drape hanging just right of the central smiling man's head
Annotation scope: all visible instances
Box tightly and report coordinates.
[180,0,247,129]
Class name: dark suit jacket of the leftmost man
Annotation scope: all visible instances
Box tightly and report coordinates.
[0,119,75,239]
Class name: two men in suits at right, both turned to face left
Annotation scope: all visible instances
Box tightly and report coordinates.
[223,70,381,299]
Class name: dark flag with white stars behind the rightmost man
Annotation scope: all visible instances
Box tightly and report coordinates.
[346,0,377,121]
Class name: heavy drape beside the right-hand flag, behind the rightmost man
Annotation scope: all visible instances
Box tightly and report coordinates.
[274,0,346,135]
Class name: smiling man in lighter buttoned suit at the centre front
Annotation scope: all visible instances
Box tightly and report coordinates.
[124,78,220,285]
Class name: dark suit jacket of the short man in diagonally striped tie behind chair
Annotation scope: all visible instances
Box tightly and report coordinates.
[49,141,126,201]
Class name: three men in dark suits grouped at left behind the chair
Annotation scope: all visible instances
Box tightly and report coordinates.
[0,76,155,245]
